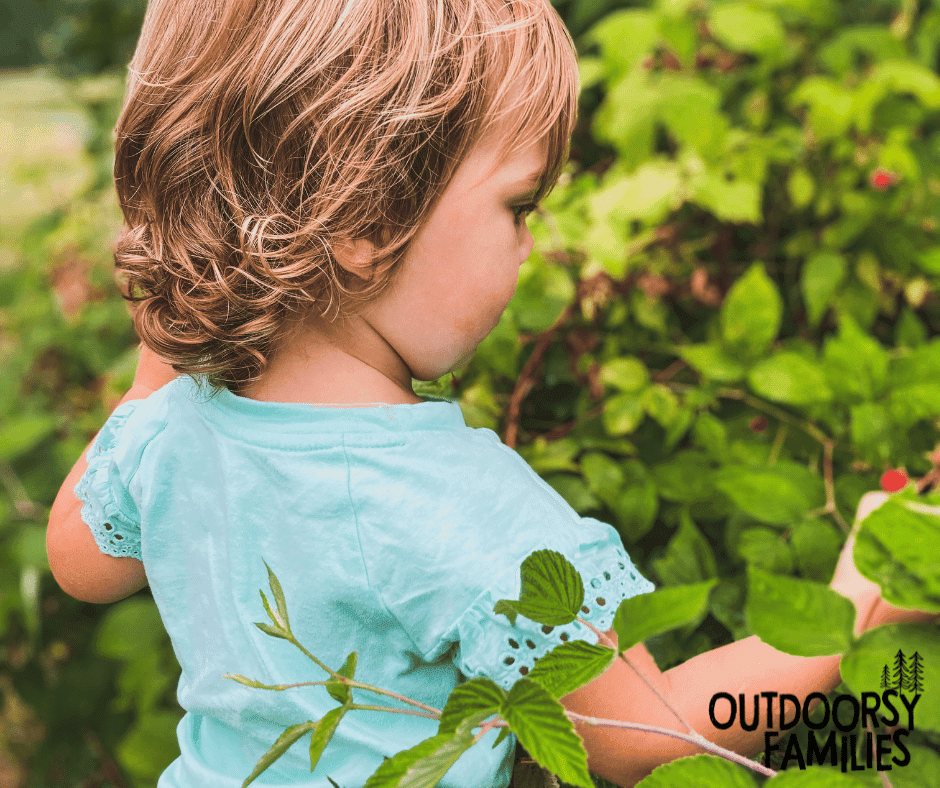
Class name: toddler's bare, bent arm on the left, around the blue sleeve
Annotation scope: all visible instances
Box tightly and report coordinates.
[46,346,177,603]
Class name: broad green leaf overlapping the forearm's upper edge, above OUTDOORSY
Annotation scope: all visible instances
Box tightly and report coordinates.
[746,566,855,657]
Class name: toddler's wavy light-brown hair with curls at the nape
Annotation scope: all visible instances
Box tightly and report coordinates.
[114,0,578,392]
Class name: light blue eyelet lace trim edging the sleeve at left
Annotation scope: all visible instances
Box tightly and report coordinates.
[75,401,141,560]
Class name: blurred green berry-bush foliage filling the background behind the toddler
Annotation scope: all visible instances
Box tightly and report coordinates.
[0,0,940,788]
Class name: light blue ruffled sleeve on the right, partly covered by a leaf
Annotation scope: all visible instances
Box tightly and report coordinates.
[456,518,654,690]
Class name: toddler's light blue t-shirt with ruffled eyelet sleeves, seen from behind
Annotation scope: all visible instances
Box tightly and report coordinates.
[75,375,653,788]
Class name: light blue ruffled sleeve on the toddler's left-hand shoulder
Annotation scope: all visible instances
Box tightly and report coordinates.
[75,400,142,560]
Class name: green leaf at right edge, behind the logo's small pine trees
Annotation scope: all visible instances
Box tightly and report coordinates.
[839,624,940,733]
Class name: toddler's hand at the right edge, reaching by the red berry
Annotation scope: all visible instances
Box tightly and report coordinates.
[829,492,937,634]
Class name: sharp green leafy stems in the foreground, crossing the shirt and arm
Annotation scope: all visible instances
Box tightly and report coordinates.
[223,520,940,788]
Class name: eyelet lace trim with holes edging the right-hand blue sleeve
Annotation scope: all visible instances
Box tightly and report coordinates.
[467,548,654,690]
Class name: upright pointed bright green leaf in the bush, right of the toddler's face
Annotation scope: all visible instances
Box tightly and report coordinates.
[720,263,783,356]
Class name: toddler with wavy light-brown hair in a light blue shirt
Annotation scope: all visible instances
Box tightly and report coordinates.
[47,0,932,788]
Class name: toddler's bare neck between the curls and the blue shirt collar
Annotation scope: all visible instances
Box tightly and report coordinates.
[239,312,424,407]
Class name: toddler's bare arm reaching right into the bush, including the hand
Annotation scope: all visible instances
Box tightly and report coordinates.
[562,494,936,786]
